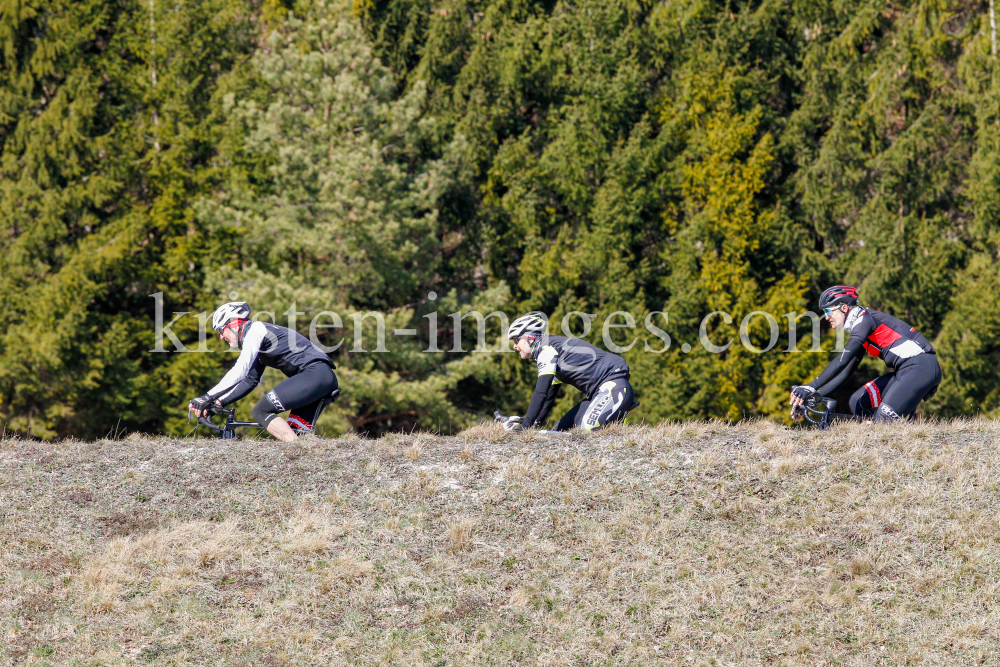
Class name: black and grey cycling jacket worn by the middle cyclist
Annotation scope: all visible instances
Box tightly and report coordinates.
[522,336,629,427]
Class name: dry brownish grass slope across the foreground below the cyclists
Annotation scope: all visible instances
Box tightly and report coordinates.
[0,421,1000,666]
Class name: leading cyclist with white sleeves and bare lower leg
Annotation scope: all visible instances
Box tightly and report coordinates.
[188,301,337,442]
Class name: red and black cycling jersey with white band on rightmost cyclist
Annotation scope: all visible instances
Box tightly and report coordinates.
[809,306,934,396]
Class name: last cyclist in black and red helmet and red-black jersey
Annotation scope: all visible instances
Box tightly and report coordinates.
[791,285,941,421]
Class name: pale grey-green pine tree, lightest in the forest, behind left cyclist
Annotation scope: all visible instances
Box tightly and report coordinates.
[194,3,507,433]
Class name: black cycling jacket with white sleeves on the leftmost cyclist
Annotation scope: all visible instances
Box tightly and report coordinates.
[207,322,336,405]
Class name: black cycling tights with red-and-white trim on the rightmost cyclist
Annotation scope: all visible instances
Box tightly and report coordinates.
[850,353,941,421]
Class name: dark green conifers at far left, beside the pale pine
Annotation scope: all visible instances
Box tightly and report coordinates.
[0,0,262,437]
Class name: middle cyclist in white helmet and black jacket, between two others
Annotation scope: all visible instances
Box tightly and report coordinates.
[503,312,635,431]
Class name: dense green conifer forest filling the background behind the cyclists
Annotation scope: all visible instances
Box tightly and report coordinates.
[0,0,1000,439]
